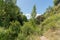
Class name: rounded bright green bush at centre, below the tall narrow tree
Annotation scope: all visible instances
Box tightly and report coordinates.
[22,22,34,35]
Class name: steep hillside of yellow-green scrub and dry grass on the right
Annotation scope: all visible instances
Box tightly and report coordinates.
[40,4,60,40]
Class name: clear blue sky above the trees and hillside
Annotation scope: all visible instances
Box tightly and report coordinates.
[17,0,53,14]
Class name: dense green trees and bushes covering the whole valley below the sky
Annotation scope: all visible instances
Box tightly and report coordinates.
[0,0,60,40]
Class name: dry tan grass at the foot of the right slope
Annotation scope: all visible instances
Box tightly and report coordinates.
[44,29,60,40]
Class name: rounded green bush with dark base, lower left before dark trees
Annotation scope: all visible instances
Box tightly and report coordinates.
[9,21,21,40]
